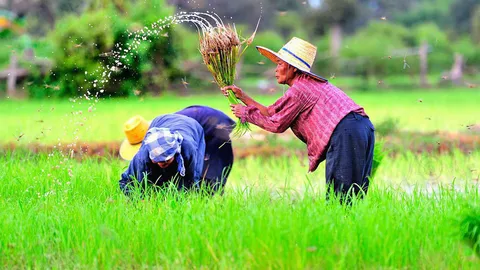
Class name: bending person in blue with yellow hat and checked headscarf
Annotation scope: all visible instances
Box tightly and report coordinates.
[119,106,235,195]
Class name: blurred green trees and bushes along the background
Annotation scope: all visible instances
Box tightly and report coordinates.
[0,0,480,97]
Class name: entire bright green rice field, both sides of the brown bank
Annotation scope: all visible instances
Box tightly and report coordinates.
[0,89,480,269]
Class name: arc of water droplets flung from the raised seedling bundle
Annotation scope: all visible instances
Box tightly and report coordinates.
[18,10,262,187]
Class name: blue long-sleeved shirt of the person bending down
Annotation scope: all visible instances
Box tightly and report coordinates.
[119,114,205,195]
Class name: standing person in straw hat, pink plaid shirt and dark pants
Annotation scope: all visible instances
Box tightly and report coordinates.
[222,37,375,202]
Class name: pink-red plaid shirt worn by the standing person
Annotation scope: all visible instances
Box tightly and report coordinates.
[241,75,368,172]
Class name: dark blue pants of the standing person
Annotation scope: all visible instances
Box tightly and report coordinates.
[325,113,375,203]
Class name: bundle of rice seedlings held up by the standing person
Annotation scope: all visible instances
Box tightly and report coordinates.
[200,24,255,136]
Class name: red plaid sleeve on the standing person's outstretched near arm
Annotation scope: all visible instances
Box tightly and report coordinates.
[241,90,304,133]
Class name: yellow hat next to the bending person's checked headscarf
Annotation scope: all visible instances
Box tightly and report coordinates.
[120,115,150,160]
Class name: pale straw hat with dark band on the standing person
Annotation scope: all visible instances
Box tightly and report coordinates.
[257,37,327,81]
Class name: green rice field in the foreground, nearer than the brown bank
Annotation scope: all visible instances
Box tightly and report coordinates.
[0,153,480,269]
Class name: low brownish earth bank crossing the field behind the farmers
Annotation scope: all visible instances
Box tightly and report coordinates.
[0,131,480,159]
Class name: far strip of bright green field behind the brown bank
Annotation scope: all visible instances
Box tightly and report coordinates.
[0,89,480,143]
